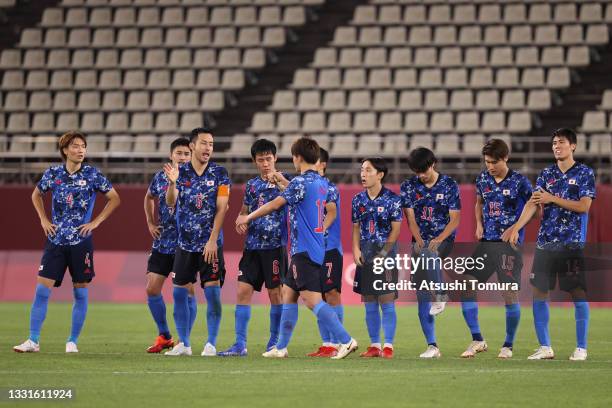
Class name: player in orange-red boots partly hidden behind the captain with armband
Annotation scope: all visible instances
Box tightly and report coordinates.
[144,137,191,353]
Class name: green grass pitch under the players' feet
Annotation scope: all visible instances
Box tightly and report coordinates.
[0,303,612,408]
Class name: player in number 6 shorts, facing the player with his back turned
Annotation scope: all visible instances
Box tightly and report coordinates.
[217,139,290,356]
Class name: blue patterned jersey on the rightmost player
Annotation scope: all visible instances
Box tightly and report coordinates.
[536,163,595,250]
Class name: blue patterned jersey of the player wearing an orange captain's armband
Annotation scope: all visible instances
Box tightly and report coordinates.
[176,162,231,252]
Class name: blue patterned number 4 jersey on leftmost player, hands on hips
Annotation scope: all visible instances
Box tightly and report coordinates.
[37,163,113,245]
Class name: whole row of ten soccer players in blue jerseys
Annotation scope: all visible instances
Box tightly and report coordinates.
[14,128,595,360]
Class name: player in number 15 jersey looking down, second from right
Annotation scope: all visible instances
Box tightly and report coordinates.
[461,139,532,359]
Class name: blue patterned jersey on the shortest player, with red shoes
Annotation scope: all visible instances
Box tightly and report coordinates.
[351,187,402,255]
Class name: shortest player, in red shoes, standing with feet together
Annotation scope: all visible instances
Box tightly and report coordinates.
[351,157,402,358]
